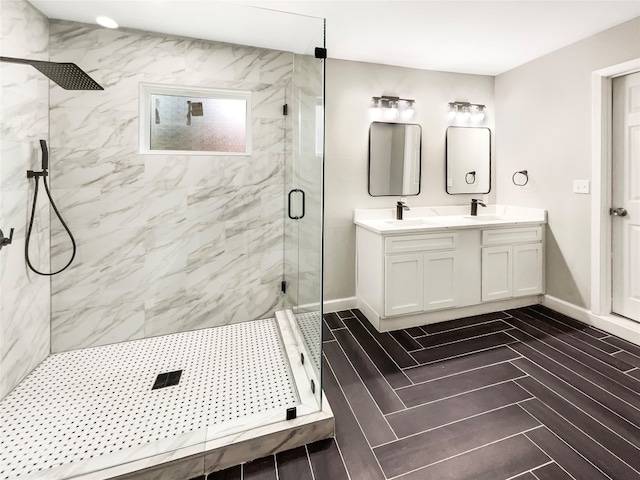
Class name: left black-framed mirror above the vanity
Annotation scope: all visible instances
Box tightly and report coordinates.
[369,122,422,197]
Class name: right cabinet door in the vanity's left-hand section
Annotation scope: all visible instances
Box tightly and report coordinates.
[424,250,458,310]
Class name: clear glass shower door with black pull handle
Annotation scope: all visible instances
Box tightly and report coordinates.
[284,39,324,404]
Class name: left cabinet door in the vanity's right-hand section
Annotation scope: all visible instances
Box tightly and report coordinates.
[482,245,513,302]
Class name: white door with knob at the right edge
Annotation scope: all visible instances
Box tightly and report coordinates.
[611,72,640,322]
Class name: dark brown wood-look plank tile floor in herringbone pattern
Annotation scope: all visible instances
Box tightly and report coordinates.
[194,306,640,480]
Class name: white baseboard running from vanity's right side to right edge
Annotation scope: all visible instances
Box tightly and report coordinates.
[542,295,640,345]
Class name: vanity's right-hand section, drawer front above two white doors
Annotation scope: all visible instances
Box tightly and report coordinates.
[482,226,544,302]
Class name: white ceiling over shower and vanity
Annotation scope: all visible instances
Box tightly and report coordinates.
[30,0,640,75]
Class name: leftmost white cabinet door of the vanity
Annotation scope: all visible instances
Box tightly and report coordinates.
[384,253,424,317]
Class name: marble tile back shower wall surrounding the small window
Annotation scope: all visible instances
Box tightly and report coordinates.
[50,21,293,352]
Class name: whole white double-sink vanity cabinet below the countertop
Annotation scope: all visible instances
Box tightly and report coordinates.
[356,216,544,332]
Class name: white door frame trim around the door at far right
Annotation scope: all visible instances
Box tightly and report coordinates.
[591,58,640,321]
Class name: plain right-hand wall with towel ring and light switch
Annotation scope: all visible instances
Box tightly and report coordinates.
[495,17,640,309]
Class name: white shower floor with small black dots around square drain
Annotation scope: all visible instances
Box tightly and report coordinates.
[0,319,298,479]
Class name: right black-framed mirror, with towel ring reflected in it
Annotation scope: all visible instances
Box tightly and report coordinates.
[446,127,491,195]
